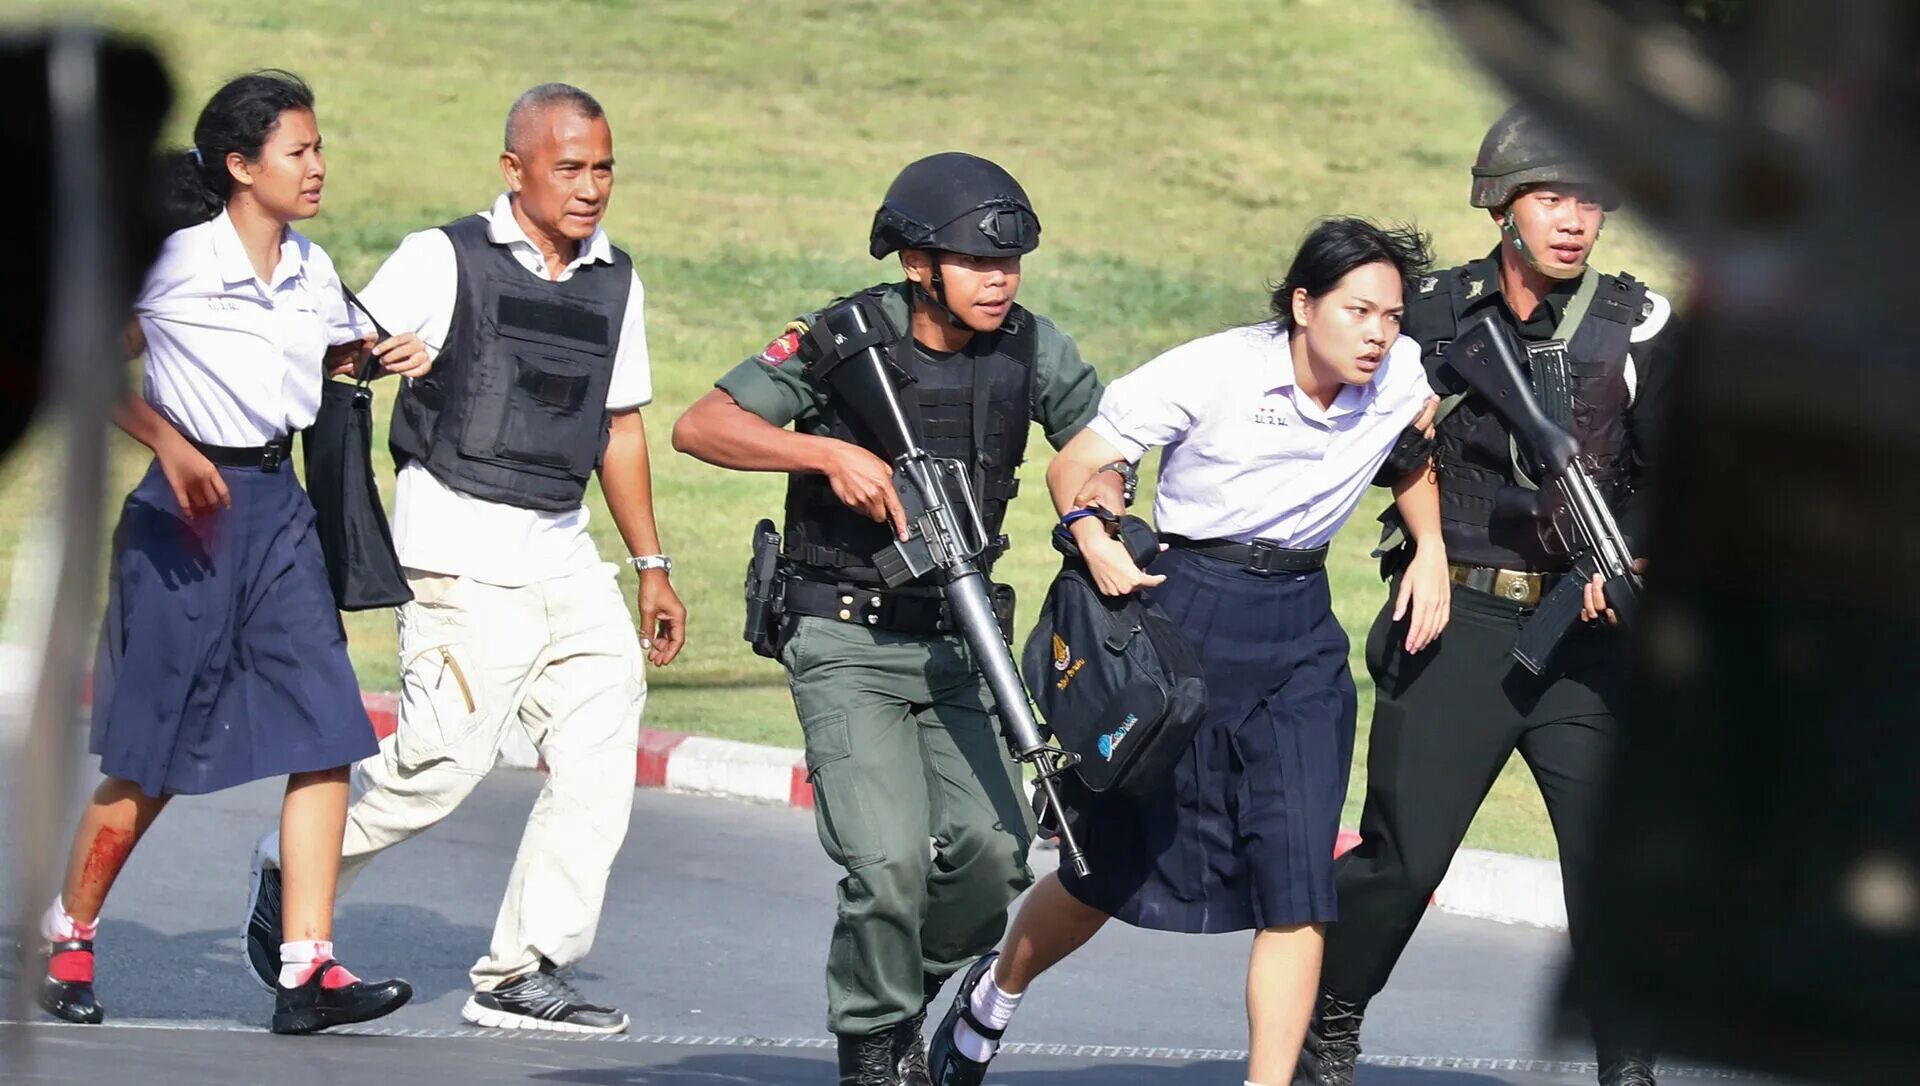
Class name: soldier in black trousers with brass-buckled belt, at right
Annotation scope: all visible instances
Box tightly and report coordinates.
[1294,109,1678,1086]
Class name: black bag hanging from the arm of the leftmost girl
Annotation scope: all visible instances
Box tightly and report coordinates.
[300,284,413,610]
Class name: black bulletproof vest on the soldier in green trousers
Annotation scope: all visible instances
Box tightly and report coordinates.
[781,286,1039,585]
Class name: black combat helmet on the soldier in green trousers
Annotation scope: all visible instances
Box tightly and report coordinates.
[868,152,1041,259]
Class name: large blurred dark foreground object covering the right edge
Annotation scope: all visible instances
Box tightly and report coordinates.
[1434,0,1920,1084]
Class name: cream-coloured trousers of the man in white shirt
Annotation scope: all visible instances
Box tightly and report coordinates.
[340,562,647,990]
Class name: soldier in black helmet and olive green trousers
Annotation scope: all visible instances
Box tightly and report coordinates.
[674,152,1121,1086]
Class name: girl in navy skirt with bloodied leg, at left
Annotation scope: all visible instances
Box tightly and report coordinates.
[40,71,428,1032]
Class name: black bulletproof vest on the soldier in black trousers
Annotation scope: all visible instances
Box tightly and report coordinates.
[1407,265,1647,572]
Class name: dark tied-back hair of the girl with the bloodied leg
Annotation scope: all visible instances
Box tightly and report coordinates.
[161,67,313,230]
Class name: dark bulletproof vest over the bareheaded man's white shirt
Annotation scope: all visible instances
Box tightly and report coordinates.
[388,215,634,512]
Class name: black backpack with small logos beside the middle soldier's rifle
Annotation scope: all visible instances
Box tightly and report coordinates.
[1021,516,1206,806]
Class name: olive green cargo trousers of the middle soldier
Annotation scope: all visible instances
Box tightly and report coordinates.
[781,618,1033,1034]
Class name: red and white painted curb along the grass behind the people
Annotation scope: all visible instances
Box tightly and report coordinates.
[361,693,1567,931]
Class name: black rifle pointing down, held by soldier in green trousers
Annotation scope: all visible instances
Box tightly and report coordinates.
[806,295,1089,875]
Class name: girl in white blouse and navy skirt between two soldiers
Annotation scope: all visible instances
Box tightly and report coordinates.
[929,219,1450,1086]
